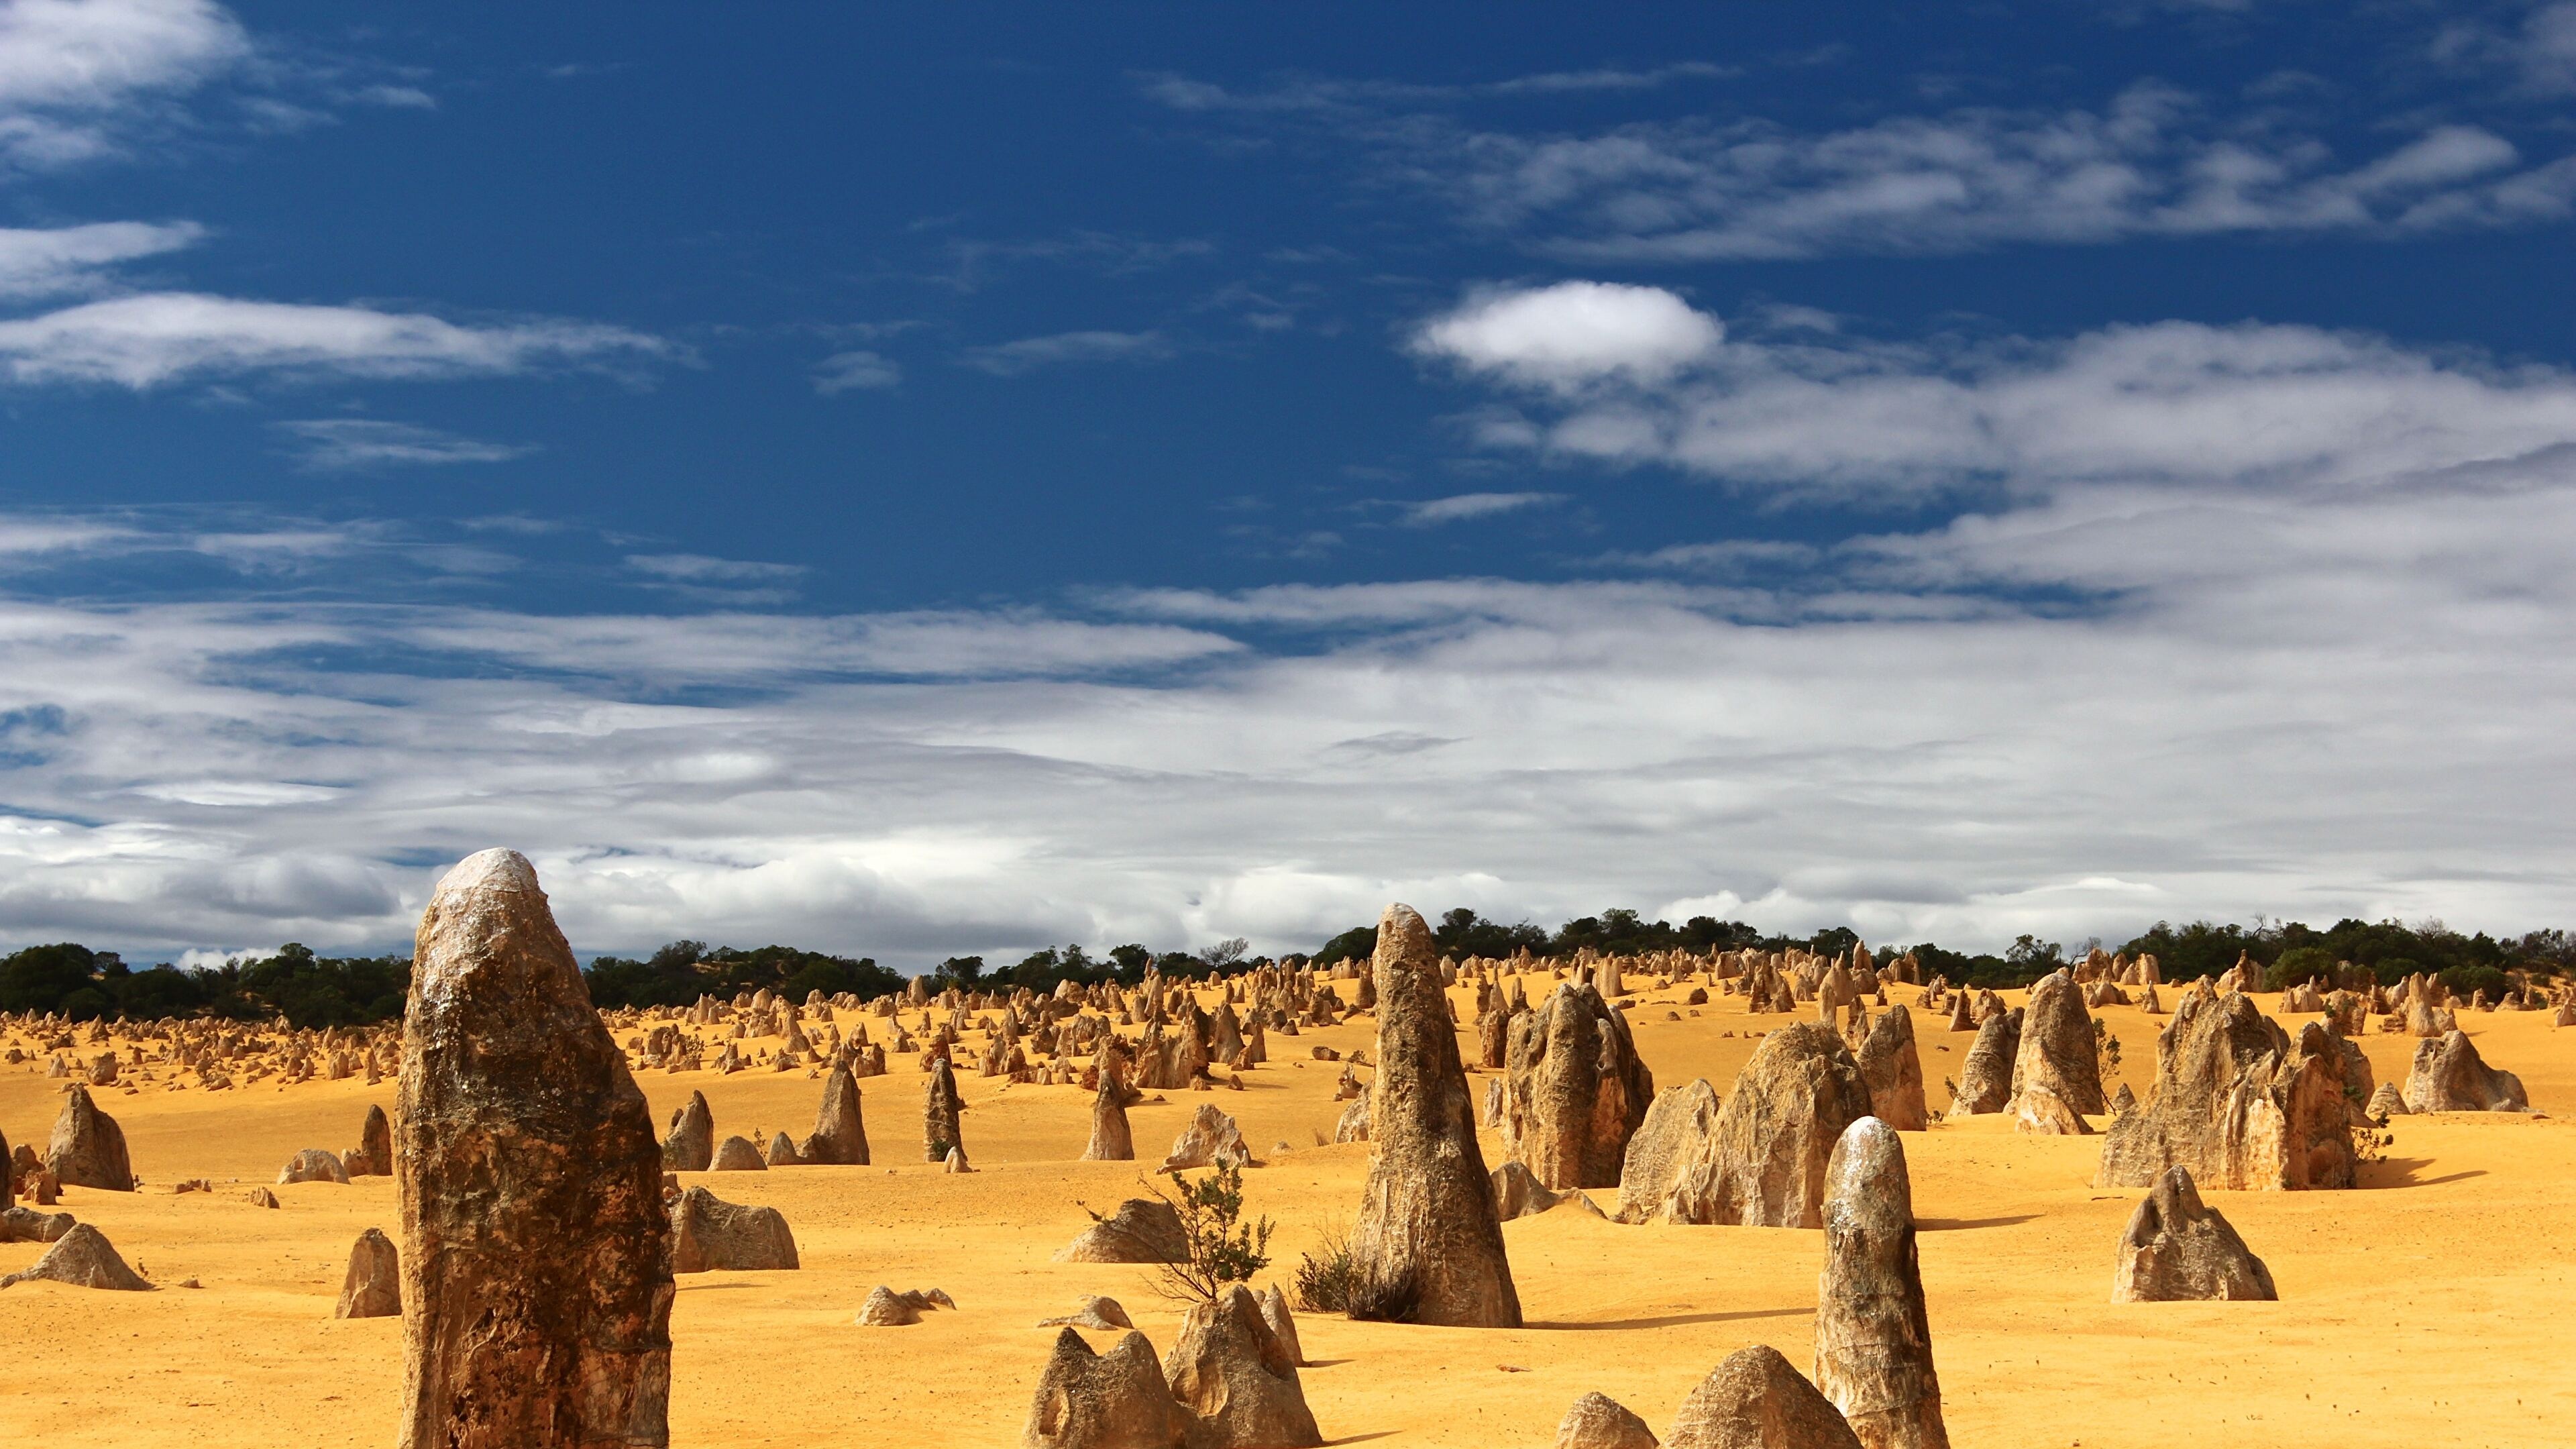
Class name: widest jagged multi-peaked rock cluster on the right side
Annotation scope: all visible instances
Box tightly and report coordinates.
[2094,979,2367,1191]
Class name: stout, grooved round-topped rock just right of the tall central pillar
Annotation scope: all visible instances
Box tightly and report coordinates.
[1502,982,1654,1191]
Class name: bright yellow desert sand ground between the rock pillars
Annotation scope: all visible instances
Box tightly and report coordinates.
[0,977,2576,1449]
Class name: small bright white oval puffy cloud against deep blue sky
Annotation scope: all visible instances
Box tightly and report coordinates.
[1414,281,1726,387]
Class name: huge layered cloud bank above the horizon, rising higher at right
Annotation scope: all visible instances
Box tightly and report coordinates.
[15,305,2576,964]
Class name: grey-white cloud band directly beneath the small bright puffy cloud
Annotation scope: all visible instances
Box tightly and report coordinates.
[1442,291,2576,498]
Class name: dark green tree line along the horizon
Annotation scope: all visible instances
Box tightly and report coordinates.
[0,908,2576,1029]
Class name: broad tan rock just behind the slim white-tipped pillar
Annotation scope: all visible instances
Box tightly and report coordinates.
[1664,1021,1870,1227]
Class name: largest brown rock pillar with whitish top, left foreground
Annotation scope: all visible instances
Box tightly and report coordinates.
[394,851,672,1449]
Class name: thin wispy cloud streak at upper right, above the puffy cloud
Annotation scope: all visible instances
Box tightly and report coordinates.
[1146,70,2576,263]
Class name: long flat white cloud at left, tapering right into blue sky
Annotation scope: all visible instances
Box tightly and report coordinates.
[0,291,675,389]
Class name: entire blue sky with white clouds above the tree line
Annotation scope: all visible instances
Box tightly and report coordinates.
[0,0,2576,964]
